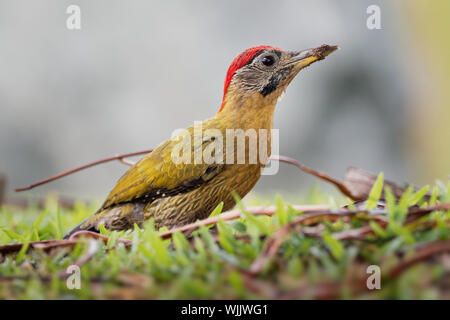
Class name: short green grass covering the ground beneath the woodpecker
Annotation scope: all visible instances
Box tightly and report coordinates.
[0,180,450,299]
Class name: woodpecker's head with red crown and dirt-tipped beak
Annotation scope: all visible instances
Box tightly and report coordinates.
[219,44,338,112]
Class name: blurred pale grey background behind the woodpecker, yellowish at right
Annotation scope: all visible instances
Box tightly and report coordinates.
[0,0,450,200]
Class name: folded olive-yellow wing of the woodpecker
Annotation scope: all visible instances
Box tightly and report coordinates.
[99,127,224,211]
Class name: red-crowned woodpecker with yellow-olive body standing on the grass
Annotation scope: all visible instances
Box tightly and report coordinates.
[64,45,338,238]
